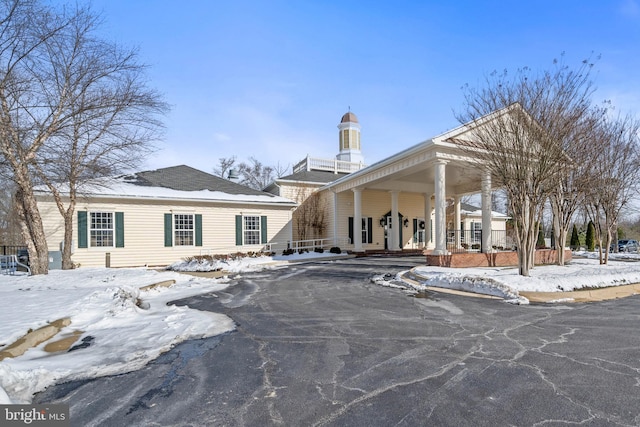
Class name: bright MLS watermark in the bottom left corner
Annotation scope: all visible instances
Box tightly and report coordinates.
[0,405,70,427]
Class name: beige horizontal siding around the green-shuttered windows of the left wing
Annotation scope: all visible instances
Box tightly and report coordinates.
[38,196,291,267]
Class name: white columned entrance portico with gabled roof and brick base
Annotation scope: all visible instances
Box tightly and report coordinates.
[321,118,492,255]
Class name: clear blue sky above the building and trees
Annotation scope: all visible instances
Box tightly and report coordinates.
[86,0,640,172]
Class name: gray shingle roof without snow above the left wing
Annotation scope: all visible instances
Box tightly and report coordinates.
[125,165,273,197]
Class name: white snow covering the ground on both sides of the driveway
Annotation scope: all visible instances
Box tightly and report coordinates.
[0,253,640,404]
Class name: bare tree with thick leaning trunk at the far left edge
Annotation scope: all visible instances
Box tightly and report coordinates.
[0,0,77,274]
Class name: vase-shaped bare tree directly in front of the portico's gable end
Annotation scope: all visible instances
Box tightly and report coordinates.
[458,55,593,276]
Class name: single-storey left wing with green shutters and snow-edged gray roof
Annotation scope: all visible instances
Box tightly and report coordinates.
[37,165,296,267]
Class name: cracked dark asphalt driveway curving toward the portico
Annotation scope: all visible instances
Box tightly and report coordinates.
[36,257,640,426]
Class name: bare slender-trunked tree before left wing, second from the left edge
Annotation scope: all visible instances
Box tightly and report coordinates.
[35,9,167,269]
